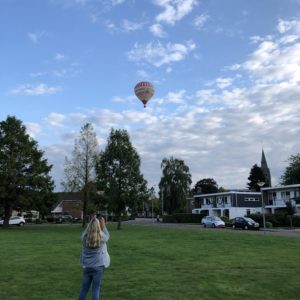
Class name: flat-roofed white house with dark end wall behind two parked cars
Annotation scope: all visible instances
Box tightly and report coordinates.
[192,191,262,219]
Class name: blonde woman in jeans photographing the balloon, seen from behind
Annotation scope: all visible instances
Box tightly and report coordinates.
[78,216,109,300]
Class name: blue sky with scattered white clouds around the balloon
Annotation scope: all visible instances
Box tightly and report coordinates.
[0,0,300,190]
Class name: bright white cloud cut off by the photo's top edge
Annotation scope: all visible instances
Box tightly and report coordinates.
[153,0,198,25]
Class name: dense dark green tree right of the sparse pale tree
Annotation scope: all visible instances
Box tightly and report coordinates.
[96,129,149,229]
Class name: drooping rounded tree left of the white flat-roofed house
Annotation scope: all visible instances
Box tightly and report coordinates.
[159,156,192,214]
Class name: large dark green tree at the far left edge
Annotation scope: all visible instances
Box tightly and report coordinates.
[0,116,54,227]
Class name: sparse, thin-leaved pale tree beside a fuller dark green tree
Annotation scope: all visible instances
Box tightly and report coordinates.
[61,123,99,226]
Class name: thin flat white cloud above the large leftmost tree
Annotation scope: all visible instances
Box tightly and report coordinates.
[10,83,62,96]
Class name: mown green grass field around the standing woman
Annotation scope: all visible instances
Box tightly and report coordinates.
[0,224,300,300]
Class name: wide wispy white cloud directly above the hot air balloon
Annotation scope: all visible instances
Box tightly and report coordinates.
[128,41,196,67]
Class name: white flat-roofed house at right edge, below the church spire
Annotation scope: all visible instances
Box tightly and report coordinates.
[261,184,300,214]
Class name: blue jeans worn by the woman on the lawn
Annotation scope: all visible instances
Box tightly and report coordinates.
[78,266,104,300]
